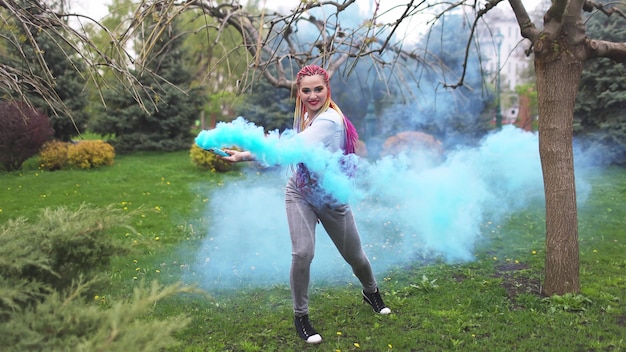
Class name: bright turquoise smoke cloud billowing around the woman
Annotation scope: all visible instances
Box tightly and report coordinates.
[192,118,589,288]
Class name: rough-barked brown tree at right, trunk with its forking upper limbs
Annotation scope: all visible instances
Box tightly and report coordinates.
[509,0,626,296]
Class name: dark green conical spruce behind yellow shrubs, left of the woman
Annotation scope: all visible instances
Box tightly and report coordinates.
[89,17,204,153]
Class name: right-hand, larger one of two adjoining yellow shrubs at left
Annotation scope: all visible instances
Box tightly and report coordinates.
[67,140,115,169]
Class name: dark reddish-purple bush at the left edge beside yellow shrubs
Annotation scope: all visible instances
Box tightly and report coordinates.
[0,101,54,171]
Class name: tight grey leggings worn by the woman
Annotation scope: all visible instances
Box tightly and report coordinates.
[285,177,377,316]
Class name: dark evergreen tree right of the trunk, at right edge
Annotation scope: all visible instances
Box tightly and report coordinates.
[574,6,626,165]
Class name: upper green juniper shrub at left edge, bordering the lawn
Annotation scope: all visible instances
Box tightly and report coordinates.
[0,205,128,294]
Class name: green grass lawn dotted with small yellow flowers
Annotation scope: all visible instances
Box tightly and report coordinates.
[0,152,626,351]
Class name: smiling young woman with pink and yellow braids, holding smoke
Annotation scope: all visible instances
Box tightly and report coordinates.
[223,65,391,344]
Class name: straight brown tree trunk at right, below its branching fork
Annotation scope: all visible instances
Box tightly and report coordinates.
[535,51,582,296]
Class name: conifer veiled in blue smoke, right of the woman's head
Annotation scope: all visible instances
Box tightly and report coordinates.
[376,13,493,149]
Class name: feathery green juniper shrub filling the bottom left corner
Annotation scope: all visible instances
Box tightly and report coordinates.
[0,282,195,352]
